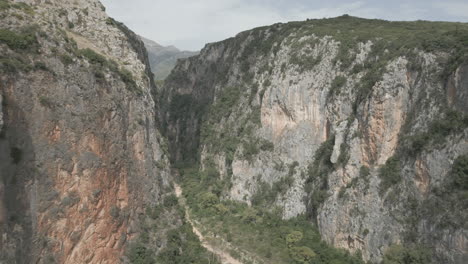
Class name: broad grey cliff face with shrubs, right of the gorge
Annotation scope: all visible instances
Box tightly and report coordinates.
[162,16,468,263]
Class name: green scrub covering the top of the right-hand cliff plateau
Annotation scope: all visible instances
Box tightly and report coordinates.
[231,16,468,111]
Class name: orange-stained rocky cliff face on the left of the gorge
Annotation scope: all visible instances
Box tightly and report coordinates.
[0,0,172,263]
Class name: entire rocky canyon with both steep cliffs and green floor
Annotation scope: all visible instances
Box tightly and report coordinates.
[0,0,468,264]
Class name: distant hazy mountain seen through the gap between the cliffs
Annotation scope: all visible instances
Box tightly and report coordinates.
[140,36,198,80]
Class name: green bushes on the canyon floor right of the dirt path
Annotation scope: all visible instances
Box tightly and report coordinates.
[180,163,364,264]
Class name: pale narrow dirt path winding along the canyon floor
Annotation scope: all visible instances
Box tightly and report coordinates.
[174,184,243,264]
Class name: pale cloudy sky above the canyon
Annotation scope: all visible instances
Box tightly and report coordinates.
[101,0,468,51]
